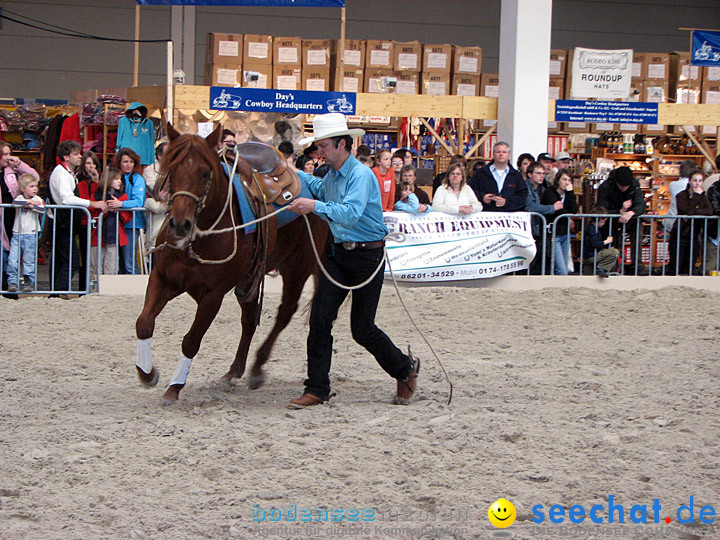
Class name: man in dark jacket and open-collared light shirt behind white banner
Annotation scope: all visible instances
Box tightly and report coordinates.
[468,142,527,212]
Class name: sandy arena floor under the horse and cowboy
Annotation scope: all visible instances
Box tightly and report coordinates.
[0,286,720,540]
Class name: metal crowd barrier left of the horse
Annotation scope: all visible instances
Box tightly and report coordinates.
[0,204,157,295]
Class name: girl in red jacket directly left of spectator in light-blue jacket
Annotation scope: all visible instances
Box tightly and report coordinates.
[90,167,132,275]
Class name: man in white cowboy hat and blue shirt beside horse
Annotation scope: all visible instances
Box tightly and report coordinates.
[290,113,420,408]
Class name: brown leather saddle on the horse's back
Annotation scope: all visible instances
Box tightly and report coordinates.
[235,142,301,204]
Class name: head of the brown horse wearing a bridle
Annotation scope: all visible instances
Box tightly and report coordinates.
[161,124,225,247]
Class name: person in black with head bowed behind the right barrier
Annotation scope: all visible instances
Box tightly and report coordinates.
[597,167,646,274]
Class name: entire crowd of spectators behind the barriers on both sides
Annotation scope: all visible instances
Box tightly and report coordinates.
[0,130,720,293]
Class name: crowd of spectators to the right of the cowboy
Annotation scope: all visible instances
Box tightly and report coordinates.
[334,142,720,277]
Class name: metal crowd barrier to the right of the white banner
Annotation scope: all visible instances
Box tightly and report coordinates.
[550,214,720,276]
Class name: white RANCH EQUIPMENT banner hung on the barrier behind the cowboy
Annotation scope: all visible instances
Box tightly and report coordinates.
[384,212,535,281]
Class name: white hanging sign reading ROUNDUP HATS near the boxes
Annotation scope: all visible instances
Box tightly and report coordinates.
[571,47,632,99]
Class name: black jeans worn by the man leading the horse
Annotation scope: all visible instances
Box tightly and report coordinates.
[305,244,410,399]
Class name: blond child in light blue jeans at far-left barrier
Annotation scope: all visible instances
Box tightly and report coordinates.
[7,174,45,292]
